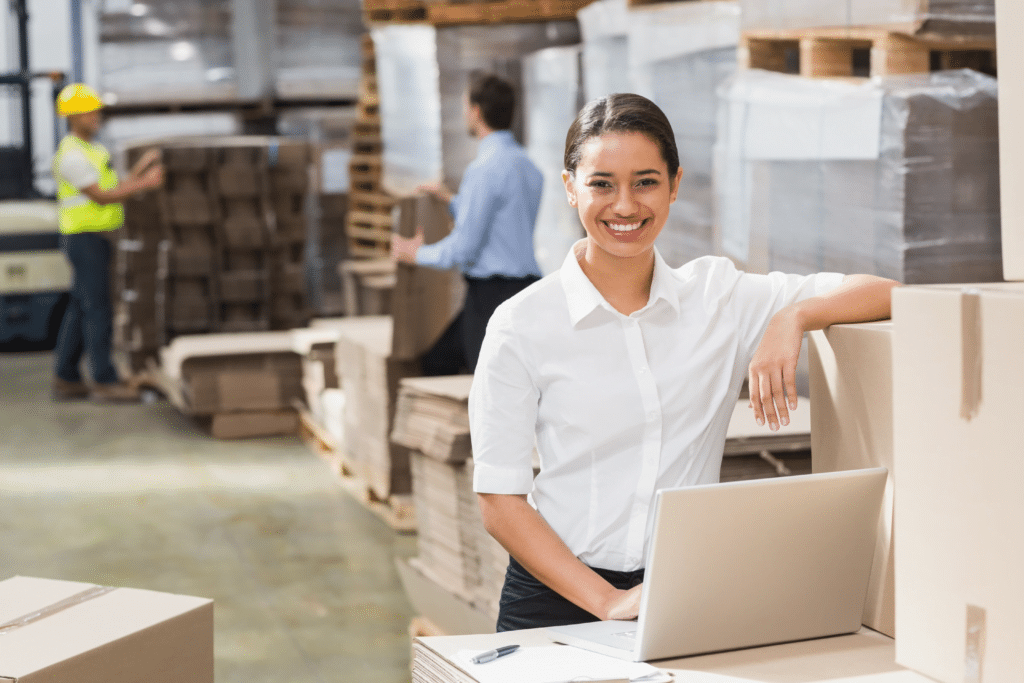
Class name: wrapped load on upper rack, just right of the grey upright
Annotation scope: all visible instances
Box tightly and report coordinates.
[276,0,365,97]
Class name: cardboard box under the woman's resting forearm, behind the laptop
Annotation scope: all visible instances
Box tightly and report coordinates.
[809,322,896,637]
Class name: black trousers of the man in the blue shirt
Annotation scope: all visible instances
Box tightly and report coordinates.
[422,275,540,377]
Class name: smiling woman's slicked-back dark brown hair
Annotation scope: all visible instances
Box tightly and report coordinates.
[564,93,679,179]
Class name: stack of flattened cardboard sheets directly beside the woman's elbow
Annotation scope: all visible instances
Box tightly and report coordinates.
[391,375,508,617]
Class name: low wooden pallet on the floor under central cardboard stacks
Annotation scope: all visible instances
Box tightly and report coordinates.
[295,401,416,533]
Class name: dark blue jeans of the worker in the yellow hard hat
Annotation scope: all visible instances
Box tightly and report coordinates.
[55,232,118,384]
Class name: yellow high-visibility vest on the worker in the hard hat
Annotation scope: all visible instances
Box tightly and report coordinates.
[53,135,125,234]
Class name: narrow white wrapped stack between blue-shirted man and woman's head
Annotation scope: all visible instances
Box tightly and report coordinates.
[522,46,584,274]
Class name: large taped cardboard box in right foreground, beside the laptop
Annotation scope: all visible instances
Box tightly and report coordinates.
[893,284,1024,683]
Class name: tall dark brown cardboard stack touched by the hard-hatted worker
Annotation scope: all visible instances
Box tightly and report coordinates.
[115,136,311,371]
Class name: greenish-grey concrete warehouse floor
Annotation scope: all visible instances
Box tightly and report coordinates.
[0,353,416,683]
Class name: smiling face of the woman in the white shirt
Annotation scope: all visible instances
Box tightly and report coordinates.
[562,132,682,258]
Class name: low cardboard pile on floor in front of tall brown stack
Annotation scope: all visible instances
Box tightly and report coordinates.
[161,332,304,438]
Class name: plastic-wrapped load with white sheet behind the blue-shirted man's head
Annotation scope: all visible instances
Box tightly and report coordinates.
[373,22,580,195]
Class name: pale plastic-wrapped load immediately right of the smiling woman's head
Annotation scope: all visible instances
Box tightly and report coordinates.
[629,2,739,266]
